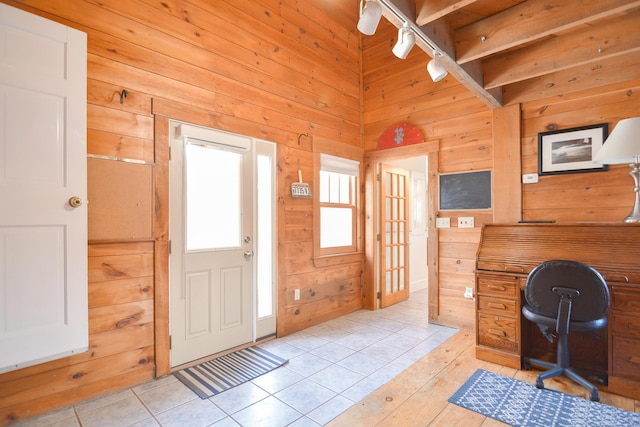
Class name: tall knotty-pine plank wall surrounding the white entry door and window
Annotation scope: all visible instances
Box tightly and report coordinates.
[0,0,362,425]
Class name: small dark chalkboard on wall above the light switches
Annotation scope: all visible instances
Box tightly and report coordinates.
[440,170,491,210]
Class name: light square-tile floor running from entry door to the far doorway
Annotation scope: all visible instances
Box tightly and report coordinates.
[17,290,457,427]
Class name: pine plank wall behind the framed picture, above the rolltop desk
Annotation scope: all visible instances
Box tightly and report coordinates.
[521,80,640,222]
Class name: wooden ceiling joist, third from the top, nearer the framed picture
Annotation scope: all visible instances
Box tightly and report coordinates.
[482,10,640,89]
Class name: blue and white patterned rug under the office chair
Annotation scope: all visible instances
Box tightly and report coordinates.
[449,369,640,427]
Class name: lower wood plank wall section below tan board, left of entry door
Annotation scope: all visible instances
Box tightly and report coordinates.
[0,242,154,425]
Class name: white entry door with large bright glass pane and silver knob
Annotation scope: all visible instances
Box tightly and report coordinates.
[170,124,254,366]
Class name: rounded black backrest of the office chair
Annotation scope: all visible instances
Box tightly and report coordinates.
[524,260,609,322]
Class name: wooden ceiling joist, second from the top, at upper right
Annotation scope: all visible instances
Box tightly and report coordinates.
[454,0,640,64]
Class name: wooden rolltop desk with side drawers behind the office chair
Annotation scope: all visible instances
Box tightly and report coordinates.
[475,223,640,399]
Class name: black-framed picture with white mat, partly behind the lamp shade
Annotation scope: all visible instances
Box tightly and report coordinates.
[538,123,609,175]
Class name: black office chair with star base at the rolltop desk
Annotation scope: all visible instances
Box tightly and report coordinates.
[522,260,609,402]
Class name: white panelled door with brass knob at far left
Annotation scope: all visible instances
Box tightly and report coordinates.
[0,4,88,372]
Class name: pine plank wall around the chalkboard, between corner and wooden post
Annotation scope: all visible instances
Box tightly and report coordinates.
[363,20,493,329]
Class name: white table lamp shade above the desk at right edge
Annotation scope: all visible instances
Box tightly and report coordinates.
[593,117,640,165]
